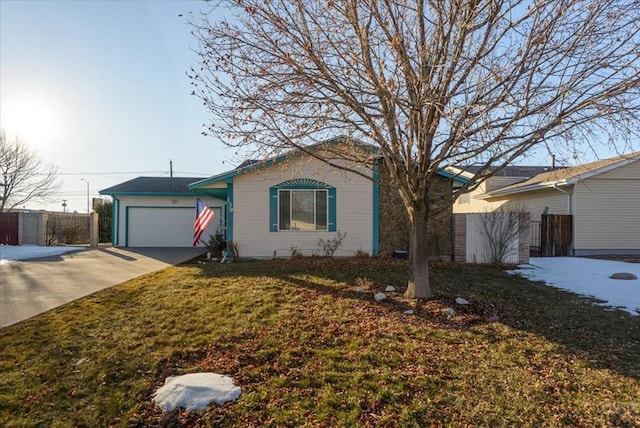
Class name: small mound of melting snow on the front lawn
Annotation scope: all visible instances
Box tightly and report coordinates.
[153,373,242,412]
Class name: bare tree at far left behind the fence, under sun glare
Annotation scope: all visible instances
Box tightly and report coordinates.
[0,131,59,212]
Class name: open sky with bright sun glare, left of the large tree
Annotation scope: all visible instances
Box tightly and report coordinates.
[0,0,230,212]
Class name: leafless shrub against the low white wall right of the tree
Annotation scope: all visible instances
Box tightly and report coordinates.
[480,204,531,263]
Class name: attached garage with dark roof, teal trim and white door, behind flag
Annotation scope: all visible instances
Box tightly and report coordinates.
[100,177,225,247]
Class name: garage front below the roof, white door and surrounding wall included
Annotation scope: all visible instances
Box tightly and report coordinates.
[115,196,224,247]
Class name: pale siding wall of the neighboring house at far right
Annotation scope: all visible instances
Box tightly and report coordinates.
[574,161,640,255]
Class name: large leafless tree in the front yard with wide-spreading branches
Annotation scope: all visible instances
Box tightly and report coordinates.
[189,0,640,298]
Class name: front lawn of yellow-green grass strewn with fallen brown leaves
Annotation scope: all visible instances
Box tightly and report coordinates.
[0,258,640,427]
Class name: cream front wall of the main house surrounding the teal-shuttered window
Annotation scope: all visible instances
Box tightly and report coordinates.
[233,157,373,258]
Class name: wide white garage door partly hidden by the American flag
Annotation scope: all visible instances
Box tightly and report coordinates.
[127,207,221,247]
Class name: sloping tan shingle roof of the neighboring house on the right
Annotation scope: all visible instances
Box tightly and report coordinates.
[487,152,640,197]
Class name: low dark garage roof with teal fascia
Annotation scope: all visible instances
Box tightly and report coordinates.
[99,177,204,196]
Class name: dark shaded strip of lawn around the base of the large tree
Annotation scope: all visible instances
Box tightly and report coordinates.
[194,258,640,379]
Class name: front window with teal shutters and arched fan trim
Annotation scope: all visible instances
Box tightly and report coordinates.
[269,179,336,232]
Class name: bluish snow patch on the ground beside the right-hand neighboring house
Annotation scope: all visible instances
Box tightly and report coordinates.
[510,257,640,315]
